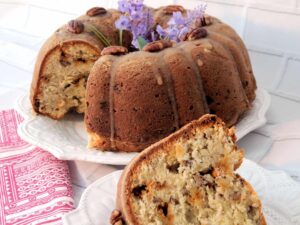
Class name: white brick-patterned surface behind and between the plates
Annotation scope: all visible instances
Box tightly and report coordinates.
[0,0,300,206]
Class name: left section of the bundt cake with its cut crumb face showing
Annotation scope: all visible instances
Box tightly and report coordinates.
[30,7,131,119]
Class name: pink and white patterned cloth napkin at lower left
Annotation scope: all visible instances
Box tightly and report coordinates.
[0,110,74,225]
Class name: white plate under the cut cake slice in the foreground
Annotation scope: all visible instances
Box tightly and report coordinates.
[63,159,300,225]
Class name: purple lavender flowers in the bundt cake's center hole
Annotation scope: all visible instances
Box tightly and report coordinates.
[115,0,207,49]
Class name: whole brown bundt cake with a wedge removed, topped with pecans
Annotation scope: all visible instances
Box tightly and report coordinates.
[31,3,256,152]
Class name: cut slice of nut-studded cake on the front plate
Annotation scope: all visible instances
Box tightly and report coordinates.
[111,115,266,225]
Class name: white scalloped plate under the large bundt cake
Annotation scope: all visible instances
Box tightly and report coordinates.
[16,89,270,165]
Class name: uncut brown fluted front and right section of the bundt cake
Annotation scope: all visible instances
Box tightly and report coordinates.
[85,6,256,152]
